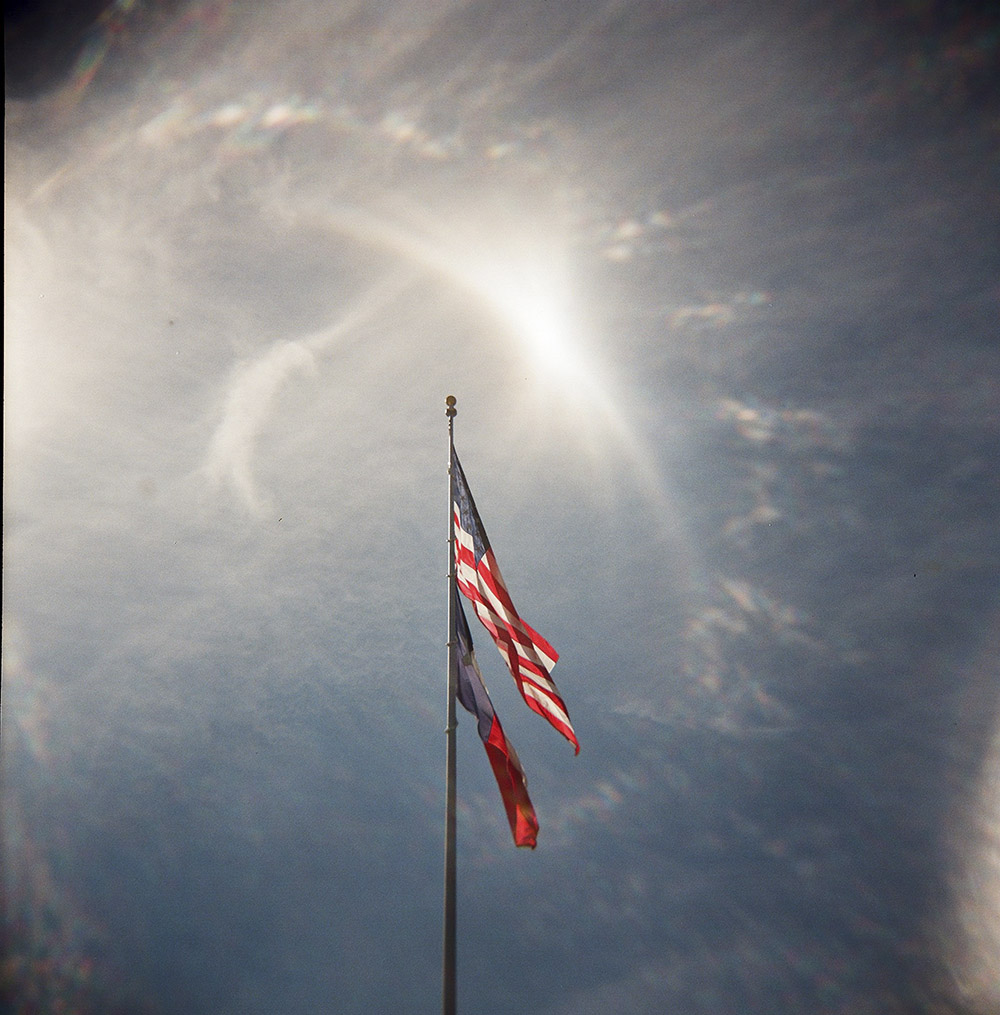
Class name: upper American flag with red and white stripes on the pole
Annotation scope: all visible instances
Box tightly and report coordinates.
[452,450,580,754]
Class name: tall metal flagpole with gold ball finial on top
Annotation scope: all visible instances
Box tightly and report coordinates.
[442,395,458,1015]
